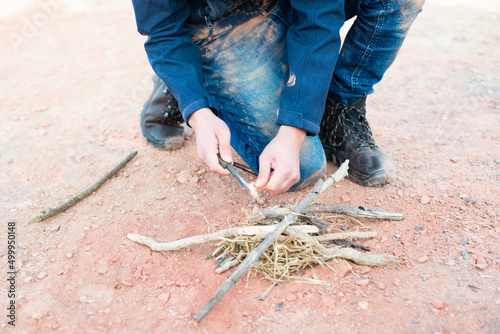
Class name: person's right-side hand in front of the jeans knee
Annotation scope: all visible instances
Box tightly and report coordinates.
[255,125,306,195]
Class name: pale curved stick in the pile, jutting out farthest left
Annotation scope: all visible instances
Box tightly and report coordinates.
[127,225,319,252]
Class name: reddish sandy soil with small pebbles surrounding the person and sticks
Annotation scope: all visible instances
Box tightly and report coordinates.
[0,0,500,333]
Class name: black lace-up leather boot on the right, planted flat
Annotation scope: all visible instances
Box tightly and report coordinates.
[319,94,396,186]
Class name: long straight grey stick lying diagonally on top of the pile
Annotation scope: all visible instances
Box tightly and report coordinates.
[191,160,349,324]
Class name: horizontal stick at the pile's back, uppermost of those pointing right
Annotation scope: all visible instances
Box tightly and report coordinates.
[248,204,404,222]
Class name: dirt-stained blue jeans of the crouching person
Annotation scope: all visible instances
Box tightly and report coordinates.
[193,0,424,190]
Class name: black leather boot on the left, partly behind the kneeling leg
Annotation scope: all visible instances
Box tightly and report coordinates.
[141,75,184,151]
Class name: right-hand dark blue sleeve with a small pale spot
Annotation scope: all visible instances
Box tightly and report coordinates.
[277,0,347,135]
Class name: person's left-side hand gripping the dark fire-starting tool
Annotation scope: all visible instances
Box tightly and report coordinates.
[188,108,233,175]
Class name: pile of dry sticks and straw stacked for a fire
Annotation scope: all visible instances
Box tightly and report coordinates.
[127,161,403,324]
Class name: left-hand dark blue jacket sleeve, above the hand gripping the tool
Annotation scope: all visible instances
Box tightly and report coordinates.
[132,0,215,122]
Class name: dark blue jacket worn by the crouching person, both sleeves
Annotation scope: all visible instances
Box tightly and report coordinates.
[132,0,344,135]
